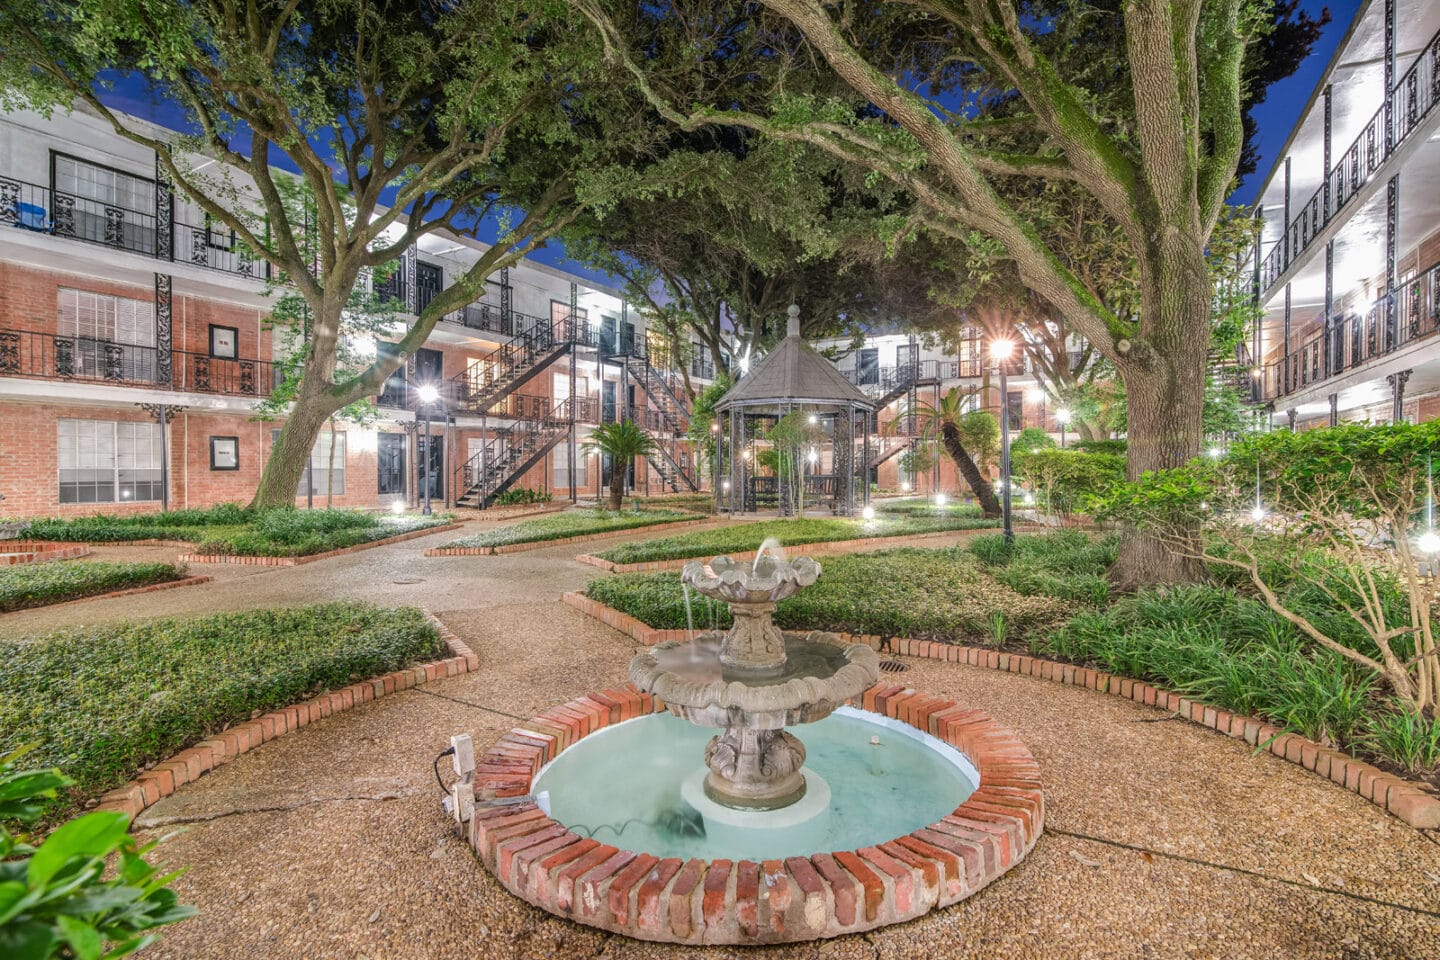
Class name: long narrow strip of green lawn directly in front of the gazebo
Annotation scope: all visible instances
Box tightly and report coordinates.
[598,517,999,563]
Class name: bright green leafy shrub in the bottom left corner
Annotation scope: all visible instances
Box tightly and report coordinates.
[0,750,196,960]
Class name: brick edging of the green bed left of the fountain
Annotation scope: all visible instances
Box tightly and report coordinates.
[96,610,480,819]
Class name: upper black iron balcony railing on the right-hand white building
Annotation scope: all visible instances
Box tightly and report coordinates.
[1260,24,1440,291]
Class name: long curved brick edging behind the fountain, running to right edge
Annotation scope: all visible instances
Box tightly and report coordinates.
[562,593,1440,830]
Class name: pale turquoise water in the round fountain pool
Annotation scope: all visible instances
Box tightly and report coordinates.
[534,707,979,861]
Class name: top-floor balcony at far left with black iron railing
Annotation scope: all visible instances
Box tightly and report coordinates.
[0,177,269,281]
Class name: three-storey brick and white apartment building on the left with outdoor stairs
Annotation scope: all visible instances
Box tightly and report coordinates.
[0,101,702,517]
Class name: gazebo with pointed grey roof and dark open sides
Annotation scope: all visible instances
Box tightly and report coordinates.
[716,304,876,517]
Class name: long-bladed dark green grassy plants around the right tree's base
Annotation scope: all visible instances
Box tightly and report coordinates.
[968,531,1440,776]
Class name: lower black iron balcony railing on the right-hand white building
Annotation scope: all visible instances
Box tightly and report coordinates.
[1261,263,1440,400]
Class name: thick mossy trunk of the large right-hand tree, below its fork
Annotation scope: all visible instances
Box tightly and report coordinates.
[1109,244,1212,592]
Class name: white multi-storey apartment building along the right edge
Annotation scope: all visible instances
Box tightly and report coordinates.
[1241,0,1440,429]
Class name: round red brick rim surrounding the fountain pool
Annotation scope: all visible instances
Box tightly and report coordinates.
[469,684,1045,944]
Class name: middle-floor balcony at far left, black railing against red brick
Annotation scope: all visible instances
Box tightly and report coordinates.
[0,330,276,399]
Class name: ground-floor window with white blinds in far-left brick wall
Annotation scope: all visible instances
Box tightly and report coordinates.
[56,420,163,504]
